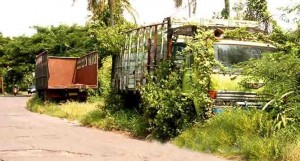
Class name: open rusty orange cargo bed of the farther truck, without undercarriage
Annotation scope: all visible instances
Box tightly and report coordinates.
[35,52,98,90]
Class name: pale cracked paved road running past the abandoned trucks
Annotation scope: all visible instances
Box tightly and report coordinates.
[0,97,224,161]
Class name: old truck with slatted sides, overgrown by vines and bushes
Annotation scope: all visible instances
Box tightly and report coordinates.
[112,18,275,112]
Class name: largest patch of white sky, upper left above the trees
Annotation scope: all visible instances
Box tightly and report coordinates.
[0,0,88,36]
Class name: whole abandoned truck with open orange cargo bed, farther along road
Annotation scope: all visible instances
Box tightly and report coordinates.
[35,51,98,101]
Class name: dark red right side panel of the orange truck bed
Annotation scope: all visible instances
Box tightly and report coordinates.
[75,52,98,88]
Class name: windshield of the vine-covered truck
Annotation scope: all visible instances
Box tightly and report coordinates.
[214,44,275,67]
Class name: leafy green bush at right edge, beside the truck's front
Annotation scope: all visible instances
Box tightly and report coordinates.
[243,53,300,130]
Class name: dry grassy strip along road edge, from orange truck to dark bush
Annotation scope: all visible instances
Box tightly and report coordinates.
[27,97,148,138]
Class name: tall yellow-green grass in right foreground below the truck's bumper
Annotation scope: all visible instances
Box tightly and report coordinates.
[174,109,289,160]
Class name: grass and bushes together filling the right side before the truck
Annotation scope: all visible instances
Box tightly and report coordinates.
[174,26,300,160]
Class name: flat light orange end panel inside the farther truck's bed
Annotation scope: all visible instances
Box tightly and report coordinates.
[48,57,76,88]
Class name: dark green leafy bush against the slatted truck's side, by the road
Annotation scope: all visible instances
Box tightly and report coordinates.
[141,61,195,140]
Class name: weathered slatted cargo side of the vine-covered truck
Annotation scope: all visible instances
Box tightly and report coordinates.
[112,21,169,91]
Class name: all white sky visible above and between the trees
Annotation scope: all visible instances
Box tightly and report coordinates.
[0,0,299,37]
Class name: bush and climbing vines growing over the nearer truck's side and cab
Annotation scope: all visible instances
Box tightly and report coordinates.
[141,28,273,139]
